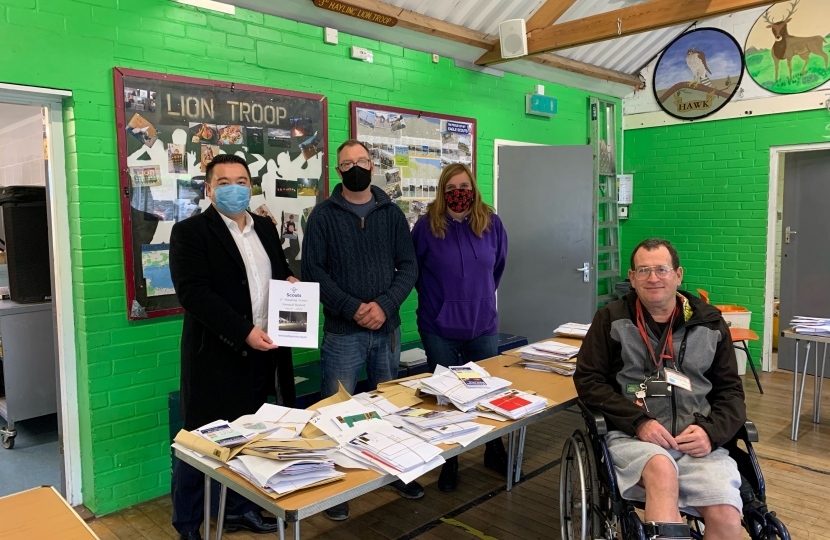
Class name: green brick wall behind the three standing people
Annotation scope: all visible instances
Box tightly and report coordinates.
[0,0,620,514]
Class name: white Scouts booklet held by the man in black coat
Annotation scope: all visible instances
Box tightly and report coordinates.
[268,279,320,349]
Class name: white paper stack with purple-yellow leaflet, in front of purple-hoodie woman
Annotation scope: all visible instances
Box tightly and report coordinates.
[420,362,510,412]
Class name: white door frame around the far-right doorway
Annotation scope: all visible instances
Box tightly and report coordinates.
[761,142,830,371]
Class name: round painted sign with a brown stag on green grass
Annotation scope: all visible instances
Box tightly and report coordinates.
[745,0,830,94]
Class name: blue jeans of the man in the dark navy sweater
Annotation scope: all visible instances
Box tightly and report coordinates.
[320,327,401,399]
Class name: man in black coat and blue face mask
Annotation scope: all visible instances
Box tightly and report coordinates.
[170,154,297,540]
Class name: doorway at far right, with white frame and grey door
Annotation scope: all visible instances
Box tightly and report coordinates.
[763,143,830,373]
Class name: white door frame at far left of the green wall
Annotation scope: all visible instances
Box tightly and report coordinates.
[0,83,83,506]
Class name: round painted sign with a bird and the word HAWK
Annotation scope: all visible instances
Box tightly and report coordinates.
[652,28,744,120]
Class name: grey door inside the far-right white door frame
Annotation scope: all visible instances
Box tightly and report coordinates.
[778,151,830,377]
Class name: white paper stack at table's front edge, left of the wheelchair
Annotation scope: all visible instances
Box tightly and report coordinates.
[344,421,444,483]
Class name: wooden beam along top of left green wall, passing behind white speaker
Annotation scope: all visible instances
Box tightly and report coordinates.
[316,0,639,86]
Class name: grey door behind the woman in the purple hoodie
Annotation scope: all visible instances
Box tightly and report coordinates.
[496,146,597,342]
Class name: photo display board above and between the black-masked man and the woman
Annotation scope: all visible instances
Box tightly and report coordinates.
[351,101,476,229]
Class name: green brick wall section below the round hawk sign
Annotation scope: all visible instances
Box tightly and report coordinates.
[621,109,830,365]
